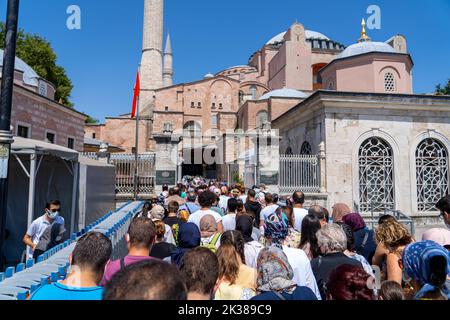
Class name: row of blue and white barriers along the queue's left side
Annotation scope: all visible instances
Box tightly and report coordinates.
[0,202,143,300]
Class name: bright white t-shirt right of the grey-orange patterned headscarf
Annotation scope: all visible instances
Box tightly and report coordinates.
[283,246,322,300]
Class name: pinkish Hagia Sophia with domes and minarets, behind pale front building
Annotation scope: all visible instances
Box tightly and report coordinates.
[86,0,412,156]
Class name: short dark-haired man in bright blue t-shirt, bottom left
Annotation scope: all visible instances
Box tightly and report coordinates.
[30,232,112,300]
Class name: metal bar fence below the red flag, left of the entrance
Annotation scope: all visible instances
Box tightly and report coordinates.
[81,152,155,199]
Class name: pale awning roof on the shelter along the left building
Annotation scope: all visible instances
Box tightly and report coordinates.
[11,137,78,162]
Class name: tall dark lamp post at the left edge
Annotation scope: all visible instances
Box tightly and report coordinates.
[0,0,19,269]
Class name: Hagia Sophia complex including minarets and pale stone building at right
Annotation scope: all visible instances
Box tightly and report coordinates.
[85,0,450,218]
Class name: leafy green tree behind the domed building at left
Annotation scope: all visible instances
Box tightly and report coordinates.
[0,22,73,107]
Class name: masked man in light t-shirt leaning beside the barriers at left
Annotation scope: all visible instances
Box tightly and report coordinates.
[23,200,65,259]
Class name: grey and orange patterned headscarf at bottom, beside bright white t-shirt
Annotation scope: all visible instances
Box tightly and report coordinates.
[257,246,297,293]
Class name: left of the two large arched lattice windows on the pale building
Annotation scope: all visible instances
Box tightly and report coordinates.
[358,137,395,212]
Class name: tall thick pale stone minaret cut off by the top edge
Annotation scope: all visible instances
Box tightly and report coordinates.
[140,0,164,115]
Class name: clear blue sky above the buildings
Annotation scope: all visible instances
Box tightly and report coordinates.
[0,0,450,121]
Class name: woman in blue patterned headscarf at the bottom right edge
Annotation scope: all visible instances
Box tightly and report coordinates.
[401,241,450,300]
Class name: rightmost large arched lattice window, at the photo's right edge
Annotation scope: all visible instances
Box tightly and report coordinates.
[416,138,449,212]
